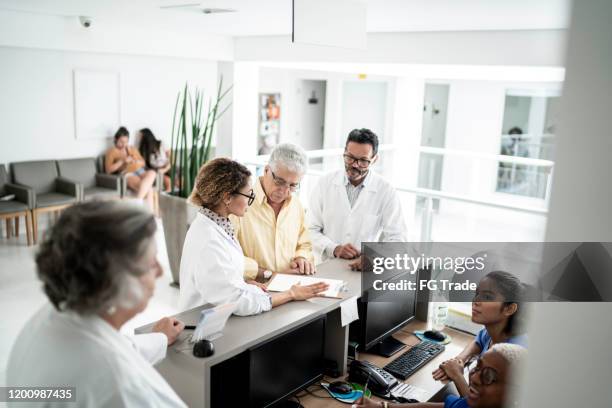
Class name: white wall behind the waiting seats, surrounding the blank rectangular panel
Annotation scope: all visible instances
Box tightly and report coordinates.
[0,47,217,167]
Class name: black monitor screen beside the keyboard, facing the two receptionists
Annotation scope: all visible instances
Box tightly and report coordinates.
[362,273,417,349]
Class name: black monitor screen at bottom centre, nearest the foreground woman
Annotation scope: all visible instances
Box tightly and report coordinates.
[249,317,325,407]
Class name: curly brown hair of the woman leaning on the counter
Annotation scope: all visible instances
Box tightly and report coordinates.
[189,157,251,210]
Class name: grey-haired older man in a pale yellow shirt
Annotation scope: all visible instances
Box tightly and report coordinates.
[231,143,315,281]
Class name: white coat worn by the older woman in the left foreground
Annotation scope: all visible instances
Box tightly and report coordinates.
[7,304,186,408]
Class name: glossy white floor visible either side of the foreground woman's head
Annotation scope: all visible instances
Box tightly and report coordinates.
[0,221,178,388]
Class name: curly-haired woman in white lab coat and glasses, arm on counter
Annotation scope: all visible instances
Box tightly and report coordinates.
[179,158,327,316]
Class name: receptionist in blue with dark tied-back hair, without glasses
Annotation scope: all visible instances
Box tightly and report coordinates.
[433,271,527,396]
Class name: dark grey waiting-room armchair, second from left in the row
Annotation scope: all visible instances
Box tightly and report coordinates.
[10,160,80,244]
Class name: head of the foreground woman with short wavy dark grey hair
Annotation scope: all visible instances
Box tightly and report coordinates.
[36,201,157,315]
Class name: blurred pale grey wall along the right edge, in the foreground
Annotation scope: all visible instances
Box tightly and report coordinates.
[520,0,612,408]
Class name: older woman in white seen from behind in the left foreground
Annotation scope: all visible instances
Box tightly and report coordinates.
[7,202,185,407]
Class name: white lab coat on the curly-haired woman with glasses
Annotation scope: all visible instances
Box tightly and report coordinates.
[179,213,272,316]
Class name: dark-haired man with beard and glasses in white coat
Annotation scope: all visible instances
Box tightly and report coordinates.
[308,129,407,269]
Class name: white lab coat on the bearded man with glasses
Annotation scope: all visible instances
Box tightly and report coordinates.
[308,170,407,260]
